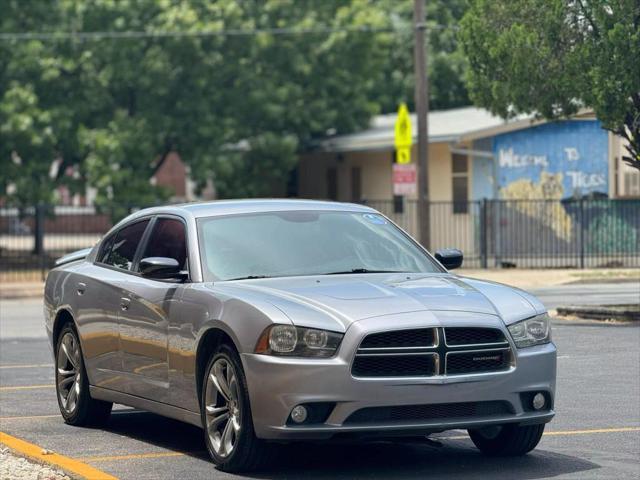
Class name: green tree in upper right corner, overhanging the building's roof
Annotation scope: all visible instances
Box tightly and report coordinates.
[460,0,640,168]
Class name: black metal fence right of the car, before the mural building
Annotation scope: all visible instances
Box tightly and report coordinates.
[367,199,640,268]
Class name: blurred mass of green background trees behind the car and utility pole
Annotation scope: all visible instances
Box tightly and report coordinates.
[0,0,466,204]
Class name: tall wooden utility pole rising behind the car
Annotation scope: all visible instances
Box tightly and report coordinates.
[413,0,431,248]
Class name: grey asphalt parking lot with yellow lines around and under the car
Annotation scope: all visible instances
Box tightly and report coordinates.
[0,288,640,480]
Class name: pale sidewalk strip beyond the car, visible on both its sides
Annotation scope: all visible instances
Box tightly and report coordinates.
[0,268,640,299]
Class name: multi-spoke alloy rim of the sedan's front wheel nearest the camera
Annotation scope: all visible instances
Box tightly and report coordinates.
[205,358,242,457]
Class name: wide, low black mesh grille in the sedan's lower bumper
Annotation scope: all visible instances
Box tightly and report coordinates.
[344,401,513,425]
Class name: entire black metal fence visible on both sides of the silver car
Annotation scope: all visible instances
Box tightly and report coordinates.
[0,199,640,282]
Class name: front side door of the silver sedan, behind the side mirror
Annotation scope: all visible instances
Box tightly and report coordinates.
[118,216,188,403]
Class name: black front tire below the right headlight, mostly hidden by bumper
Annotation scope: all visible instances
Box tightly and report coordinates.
[469,423,545,457]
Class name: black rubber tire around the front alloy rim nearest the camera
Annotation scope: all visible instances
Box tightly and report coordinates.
[200,344,271,472]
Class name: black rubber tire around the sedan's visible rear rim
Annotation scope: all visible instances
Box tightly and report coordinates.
[55,323,113,426]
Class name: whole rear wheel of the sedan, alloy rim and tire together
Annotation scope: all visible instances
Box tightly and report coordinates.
[55,323,113,426]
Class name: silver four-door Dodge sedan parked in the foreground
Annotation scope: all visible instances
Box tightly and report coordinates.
[45,200,556,471]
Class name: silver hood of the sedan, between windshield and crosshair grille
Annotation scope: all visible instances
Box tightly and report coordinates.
[212,274,545,331]
